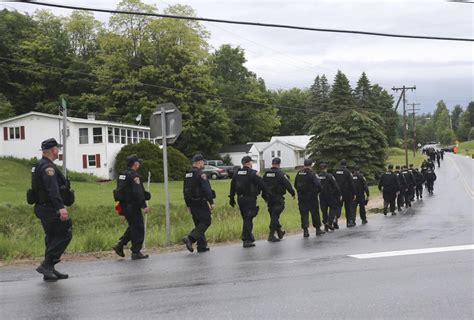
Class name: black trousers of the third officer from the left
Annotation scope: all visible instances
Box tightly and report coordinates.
[188,200,211,249]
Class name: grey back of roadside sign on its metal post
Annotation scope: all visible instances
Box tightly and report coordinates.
[150,103,183,244]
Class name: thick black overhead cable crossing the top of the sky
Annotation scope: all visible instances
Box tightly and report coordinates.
[19,1,474,42]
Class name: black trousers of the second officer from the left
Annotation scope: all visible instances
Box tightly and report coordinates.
[119,204,145,253]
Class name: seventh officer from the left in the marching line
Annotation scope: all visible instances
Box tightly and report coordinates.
[318,163,342,232]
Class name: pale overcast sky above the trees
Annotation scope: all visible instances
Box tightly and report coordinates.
[0,0,474,112]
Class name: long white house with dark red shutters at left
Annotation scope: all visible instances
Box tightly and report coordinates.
[0,112,150,179]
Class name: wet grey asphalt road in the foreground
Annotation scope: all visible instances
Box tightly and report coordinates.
[0,155,474,319]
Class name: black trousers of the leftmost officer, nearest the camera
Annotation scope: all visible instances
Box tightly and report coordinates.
[35,205,72,266]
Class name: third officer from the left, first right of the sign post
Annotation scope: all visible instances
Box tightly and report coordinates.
[183,154,215,252]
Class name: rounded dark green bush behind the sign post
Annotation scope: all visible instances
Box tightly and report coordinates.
[114,140,190,182]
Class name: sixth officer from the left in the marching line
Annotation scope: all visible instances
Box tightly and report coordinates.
[295,159,325,238]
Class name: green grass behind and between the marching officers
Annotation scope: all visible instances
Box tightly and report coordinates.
[0,149,422,261]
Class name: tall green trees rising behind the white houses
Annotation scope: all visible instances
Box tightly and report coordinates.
[0,0,472,162]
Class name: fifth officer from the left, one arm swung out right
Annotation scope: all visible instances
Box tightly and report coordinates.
[263,158,295,242]
